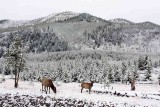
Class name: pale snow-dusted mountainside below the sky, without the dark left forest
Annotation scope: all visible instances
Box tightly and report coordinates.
[0,11,160,53]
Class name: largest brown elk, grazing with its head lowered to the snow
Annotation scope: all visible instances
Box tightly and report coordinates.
[38,77,57,94]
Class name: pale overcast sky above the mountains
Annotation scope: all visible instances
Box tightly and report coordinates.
[0,0,160,24]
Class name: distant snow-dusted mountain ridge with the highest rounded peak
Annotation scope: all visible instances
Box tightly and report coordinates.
[0,11,108,29]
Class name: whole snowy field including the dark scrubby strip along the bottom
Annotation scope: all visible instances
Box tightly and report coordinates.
[0,75,160,107]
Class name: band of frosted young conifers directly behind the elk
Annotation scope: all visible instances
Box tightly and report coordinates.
[0,51,160,83]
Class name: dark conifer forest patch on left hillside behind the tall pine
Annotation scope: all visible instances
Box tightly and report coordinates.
[0,28,68,57]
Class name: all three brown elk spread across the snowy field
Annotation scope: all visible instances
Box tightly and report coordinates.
[38,77,135,94]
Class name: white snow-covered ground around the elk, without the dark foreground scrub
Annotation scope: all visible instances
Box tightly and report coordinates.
[0,75,160,107]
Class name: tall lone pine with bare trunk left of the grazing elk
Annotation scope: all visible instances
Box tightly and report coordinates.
[4,36,26,88]
